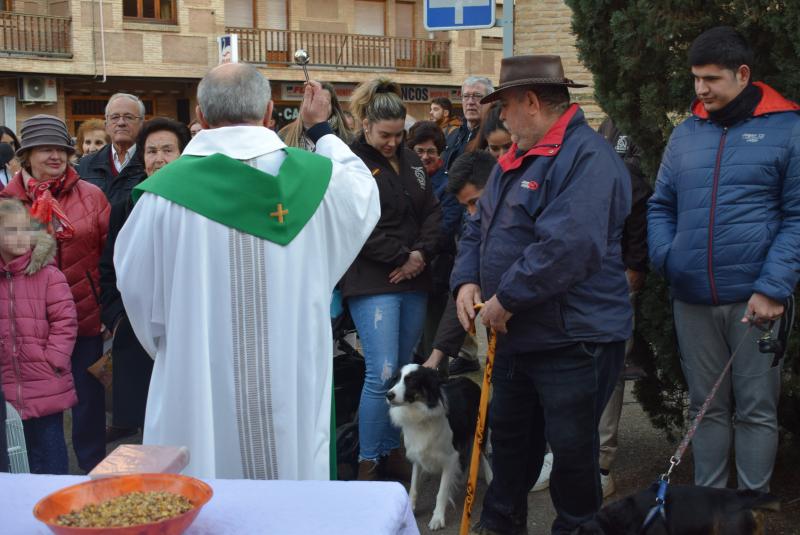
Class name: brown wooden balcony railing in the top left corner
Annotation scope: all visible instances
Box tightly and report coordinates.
[0,11,72,58]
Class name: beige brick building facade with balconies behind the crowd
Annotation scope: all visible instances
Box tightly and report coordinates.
[0,0,510,133]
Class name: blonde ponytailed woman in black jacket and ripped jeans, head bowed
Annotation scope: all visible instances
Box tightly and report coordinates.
[342,78,442,480]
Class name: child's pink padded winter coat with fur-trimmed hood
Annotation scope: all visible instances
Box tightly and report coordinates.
[0,232,78,420]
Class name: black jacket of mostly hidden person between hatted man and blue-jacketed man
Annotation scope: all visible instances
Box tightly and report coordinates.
[597,118,653,272]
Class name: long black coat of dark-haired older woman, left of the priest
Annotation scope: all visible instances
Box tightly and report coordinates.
[100,199,153,427]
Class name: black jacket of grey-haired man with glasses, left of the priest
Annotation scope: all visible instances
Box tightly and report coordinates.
[78,143,147,206]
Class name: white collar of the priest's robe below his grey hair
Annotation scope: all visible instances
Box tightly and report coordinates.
[183,126,286,160]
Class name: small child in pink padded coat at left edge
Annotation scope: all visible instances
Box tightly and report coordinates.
[0,199,78,474]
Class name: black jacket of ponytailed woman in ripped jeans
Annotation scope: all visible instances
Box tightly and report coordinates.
[342,135,442,297]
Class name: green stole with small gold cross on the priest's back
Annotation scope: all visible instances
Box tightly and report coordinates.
[132,147,337,480]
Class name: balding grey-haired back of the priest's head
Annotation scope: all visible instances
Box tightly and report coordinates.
[197,63,272,126]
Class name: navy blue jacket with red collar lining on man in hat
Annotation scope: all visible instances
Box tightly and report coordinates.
[450,104,632,354]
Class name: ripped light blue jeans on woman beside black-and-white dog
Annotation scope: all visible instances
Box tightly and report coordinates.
[348,292,428,461]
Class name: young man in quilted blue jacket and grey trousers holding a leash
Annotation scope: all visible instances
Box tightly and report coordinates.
[648,27,800,491]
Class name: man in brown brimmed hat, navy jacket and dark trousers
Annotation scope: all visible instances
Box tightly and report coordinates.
[451,56,631,534]
